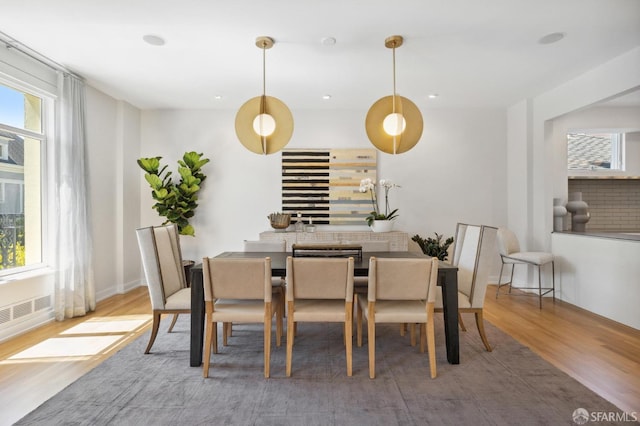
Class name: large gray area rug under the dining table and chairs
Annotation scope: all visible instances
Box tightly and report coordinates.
[17,316,620,426]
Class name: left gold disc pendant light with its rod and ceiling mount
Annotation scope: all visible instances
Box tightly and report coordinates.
[236,36,293,155]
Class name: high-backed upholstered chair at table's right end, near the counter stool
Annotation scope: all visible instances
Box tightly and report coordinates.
[435,223,497,352]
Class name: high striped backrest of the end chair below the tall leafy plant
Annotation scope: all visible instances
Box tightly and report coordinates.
[136,224,187,309]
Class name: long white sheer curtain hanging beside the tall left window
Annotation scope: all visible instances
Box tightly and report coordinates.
[48,73,96,321]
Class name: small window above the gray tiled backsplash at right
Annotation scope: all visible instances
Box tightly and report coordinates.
[567,132,624,171]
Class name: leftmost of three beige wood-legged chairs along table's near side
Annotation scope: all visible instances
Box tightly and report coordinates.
[202,257,282,378]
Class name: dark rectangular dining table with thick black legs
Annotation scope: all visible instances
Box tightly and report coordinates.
[190,251,460,367]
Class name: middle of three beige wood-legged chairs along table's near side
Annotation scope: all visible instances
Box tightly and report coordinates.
[286,256,354,377]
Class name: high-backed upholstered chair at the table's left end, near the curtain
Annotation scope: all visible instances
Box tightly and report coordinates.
[136,224,191,354]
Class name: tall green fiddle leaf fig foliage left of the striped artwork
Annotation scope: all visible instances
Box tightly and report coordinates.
[138,151,209,236]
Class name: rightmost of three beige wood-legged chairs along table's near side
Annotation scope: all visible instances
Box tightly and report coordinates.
[356,257,438,379]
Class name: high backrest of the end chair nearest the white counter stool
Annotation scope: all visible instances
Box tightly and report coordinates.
[452,223,498,308]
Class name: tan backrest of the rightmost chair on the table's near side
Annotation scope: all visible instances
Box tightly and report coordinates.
[367,257,438,302]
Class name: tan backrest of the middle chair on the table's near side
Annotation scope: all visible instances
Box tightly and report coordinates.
[287,256,354,302]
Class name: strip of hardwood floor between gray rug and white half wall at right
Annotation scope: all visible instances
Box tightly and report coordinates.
[482,285,640,413]
